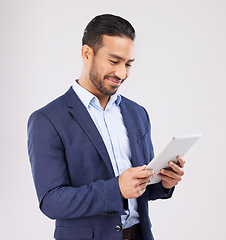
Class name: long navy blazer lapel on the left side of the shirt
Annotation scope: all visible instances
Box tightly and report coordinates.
[64,87,114,175]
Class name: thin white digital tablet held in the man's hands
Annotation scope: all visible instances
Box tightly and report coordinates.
[147,134,201,184]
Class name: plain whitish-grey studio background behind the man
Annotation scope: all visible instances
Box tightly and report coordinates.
[0,0,226,240]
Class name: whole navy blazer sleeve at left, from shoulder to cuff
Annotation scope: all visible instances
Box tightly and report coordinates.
[28,111,126,219]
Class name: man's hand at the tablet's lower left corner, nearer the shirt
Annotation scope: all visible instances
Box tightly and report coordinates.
[118,165,155,199]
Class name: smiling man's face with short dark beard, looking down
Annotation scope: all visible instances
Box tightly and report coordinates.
[89,35,134,96]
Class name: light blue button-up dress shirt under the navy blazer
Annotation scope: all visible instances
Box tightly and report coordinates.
[73,81,139,228]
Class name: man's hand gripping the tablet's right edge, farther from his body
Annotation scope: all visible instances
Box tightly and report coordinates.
[158,156,185,189]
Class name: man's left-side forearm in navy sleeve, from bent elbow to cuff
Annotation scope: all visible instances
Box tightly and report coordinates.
[40,178,125,219]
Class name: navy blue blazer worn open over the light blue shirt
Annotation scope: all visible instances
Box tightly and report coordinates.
[28,88,172,240]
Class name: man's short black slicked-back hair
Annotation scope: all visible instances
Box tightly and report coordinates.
[82,14,135,54]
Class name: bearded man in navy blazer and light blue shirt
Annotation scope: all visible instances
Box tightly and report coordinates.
[28,14,184,240]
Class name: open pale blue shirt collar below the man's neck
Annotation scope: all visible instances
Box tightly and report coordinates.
[72,80,121,108]
